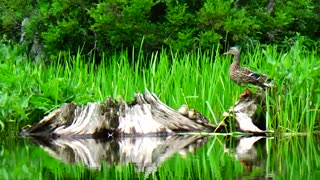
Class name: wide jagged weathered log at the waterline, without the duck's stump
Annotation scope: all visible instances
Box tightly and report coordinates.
[22,90,224,137]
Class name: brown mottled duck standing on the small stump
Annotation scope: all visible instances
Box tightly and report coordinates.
[224,47,272,88]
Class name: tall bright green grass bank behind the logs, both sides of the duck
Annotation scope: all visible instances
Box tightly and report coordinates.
[0,39,320,133]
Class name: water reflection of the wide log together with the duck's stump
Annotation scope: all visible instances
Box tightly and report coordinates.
[26,135,267,177]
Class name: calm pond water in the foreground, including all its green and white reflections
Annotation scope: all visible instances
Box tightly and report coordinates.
[0,135,320,179]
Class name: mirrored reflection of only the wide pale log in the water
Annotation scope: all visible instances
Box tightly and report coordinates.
[26,135,208,175]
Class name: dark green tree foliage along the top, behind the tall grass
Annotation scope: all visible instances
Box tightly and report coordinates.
[0,0,320,59]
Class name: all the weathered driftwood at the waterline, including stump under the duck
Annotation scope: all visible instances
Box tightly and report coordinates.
[21,89,266,138]
